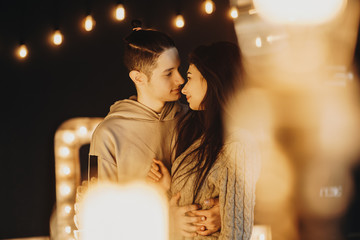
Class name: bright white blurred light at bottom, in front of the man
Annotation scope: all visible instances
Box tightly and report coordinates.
[79,183,168,240]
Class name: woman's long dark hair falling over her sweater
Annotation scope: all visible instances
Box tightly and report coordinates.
[173,42,243,201]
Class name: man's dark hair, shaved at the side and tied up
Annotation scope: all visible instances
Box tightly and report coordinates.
[124,28,175,78]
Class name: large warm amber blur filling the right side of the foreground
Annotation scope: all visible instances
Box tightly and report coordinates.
[230,0,360,240]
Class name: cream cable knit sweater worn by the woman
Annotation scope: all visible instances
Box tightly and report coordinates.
[171,131,260,240]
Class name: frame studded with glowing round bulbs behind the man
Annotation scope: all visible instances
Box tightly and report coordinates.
[54,118,103,240]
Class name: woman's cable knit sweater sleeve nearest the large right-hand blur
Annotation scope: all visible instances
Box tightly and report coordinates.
[219,138,260,240]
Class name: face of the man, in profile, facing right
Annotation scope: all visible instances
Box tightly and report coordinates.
[147,48,184,102]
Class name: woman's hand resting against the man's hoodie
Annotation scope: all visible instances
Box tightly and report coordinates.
[147,159,171,191]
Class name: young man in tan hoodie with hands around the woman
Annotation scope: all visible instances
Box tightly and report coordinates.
[89,29,220,236]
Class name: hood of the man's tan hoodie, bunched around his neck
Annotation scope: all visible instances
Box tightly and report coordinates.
[106,97,182,121]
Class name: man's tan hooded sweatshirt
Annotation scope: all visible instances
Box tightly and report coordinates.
[89,99,186,182]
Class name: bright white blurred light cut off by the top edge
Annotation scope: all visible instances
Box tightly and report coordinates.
[253,0,347,24]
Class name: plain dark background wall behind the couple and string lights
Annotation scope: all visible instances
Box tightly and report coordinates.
[0,0,360,238]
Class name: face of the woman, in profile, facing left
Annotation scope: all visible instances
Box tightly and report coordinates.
[181,64,207,110]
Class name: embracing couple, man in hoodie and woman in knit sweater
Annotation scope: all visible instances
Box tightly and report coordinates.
[89,25,260,239]
